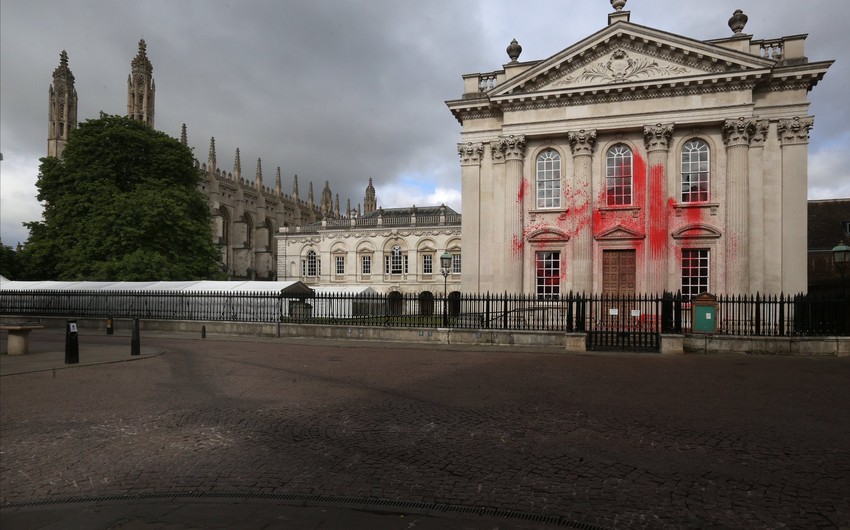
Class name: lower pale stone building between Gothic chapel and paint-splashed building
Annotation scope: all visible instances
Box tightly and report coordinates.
[276,179,463,295]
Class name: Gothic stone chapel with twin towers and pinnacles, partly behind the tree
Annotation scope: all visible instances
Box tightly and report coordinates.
[47,40,350,280]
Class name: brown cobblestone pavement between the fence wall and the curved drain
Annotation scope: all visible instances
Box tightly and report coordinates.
[0,334,850,528]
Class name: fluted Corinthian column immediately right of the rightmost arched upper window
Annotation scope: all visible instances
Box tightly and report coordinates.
[723,118,755,294]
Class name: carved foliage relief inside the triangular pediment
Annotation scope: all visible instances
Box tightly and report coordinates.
[552,49,691,88]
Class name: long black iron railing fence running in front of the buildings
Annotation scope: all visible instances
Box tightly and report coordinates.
[0,290,850,336]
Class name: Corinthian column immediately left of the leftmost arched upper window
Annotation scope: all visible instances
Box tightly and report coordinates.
[499,134,528,293]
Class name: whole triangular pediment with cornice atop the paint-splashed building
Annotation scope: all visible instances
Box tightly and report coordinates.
[487,22,775,101]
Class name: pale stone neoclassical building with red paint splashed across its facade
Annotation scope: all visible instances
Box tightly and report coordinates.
[446,0,832,297]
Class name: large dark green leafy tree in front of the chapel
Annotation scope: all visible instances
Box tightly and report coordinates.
[23,115,221,281]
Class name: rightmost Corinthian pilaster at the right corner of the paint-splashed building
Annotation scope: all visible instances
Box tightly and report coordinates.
[777,117,814,293]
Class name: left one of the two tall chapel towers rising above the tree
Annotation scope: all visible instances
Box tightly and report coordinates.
[47,50,77,158]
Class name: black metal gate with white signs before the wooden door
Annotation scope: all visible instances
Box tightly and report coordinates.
[587,295,662,352]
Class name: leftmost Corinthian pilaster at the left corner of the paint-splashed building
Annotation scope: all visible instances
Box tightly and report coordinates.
[458,142,487,293]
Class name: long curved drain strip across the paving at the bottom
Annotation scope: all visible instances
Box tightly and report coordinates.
[0,491,609,530]
